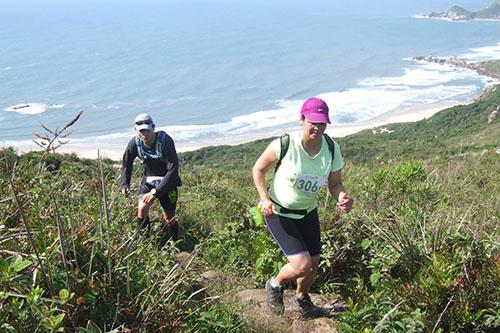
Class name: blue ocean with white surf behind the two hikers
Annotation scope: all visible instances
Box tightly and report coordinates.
[0,0,500,148]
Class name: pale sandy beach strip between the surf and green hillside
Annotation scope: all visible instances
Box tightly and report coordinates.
[3,98,462,161]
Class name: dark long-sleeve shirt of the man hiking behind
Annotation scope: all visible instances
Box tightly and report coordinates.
[121,133,181,197]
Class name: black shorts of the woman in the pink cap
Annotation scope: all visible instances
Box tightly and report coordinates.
[265,209,321,257]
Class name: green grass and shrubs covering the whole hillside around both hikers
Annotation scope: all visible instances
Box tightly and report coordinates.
[0,85,500,332]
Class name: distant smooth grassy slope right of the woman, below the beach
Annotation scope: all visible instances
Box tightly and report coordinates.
[339,88,500,161]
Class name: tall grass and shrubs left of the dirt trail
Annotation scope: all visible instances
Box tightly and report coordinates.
[0,150,243,332]
